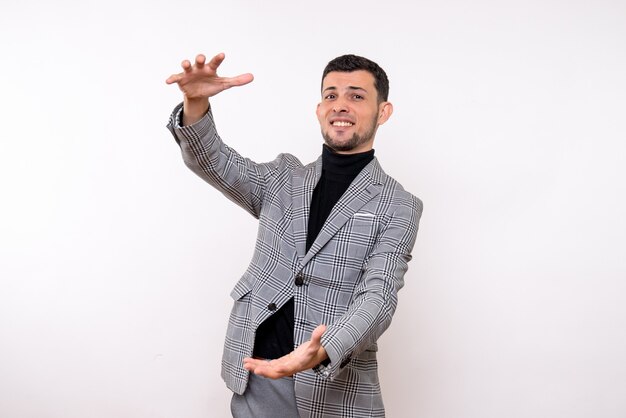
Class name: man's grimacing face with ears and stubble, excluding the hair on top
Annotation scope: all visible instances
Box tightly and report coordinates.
[317,70,393,154]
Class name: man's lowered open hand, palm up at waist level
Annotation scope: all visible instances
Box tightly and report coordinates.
[243,325,328,379]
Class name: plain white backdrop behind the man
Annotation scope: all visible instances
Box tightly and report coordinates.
[0,0,626,418]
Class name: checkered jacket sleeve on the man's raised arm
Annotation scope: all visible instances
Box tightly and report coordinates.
[167,103,295,218]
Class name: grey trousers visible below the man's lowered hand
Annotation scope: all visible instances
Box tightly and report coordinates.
[230,373,299,418]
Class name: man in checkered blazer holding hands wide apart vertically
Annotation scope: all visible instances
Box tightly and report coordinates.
[166,54,422,418]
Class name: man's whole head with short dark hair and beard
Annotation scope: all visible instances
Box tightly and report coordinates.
[317,55,393,154]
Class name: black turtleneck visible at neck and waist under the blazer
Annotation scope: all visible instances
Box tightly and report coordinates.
[253,145,374,359]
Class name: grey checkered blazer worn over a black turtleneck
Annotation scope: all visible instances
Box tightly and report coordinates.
[168,105,422,418]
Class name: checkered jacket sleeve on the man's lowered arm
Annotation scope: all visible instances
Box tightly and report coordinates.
[314,195,422,380]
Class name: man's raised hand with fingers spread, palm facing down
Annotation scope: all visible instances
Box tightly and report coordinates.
[165,53,254,125]
